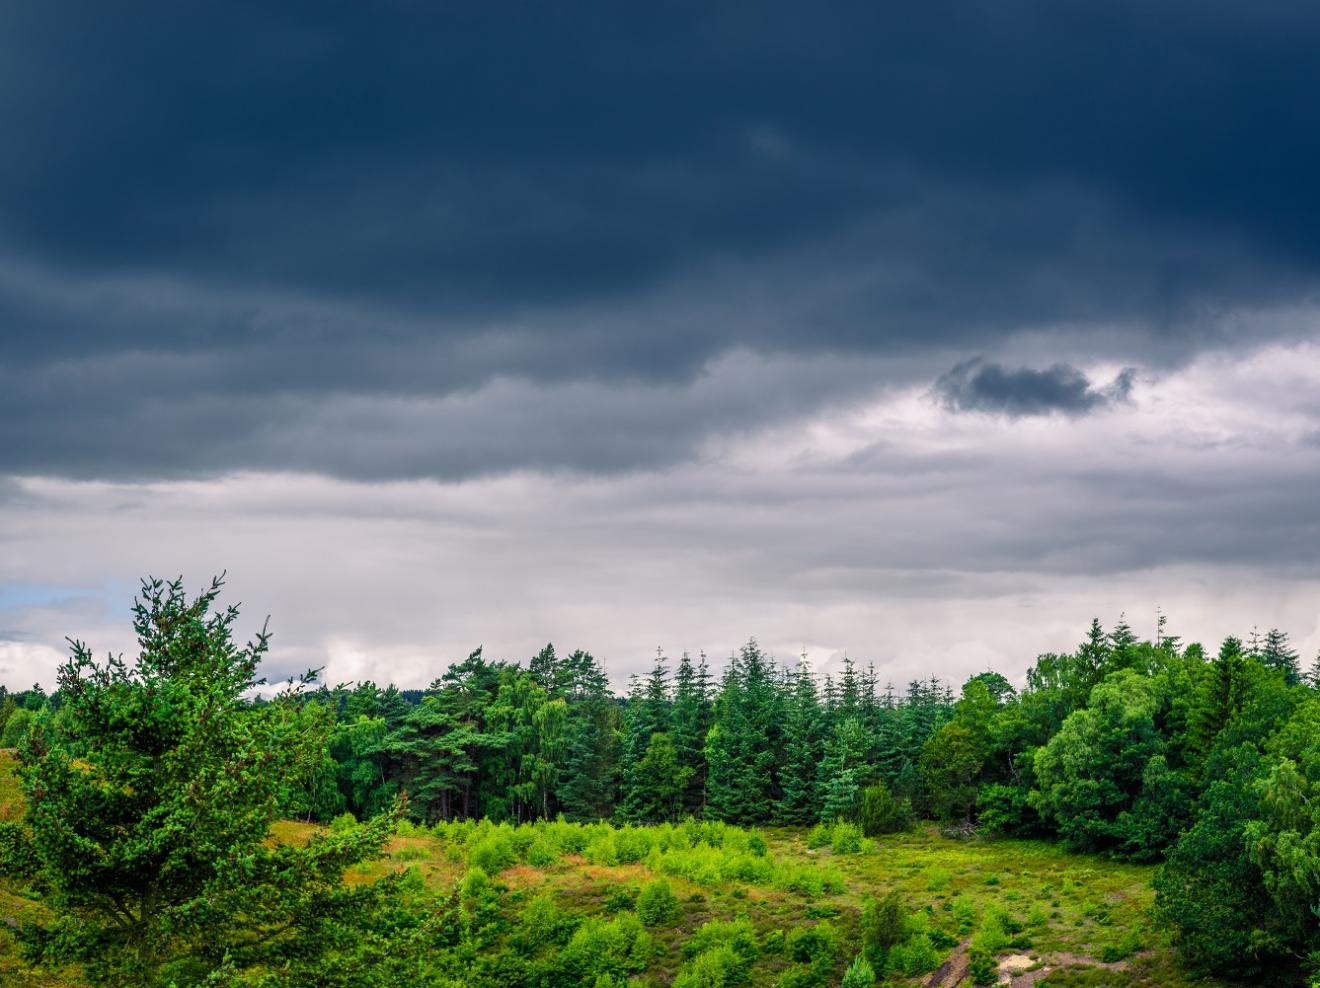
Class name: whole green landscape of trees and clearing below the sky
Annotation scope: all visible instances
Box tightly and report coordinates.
[0,580,1320,988]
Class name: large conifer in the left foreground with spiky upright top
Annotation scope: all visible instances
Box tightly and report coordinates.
[21,580,393,988]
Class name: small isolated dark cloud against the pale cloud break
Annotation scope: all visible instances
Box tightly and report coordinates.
[935,357,1137,416]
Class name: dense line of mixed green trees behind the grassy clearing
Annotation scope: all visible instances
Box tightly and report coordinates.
[0,584,1320,977]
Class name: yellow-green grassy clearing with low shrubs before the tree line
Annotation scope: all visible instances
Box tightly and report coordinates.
[0,758,1219,988]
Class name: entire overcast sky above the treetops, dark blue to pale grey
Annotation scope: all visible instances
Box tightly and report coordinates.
[0,0,1320,688]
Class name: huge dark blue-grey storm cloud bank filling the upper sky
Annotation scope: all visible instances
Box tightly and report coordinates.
[0,3,1320,477]
